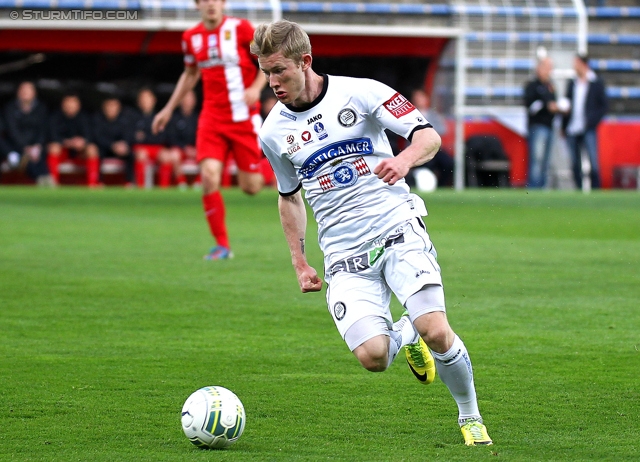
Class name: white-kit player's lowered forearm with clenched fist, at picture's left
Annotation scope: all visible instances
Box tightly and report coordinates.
[278,191,322,293]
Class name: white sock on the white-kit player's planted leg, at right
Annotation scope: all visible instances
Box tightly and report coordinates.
[431,335,480,424]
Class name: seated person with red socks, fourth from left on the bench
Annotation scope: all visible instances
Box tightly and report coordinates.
[133,88,174,188]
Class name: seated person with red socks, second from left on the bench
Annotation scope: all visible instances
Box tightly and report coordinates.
[47,93,100,187]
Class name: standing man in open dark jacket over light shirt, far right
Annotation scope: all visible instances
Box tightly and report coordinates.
[562,54,608,189]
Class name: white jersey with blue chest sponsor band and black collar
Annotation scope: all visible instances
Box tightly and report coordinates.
[260,75,430,255]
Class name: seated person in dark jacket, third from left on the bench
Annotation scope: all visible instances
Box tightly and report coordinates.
[93,97,133,186]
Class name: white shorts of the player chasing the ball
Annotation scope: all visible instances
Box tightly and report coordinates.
[325,218,442,339]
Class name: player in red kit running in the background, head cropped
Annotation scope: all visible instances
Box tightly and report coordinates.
[152,0,266,260]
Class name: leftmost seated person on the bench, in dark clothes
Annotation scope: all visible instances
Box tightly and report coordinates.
[4,82,51,185]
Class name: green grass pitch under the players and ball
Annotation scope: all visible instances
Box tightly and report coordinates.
[0,187,640,462]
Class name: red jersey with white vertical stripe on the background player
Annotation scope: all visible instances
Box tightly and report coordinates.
[182,16,260,122]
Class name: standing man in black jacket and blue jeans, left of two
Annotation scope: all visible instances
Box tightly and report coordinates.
[524,58,558,188]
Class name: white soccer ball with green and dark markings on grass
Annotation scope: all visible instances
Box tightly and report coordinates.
[182,386,245,449]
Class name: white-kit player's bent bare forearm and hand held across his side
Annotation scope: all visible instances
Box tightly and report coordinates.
[373,128,441,186]
